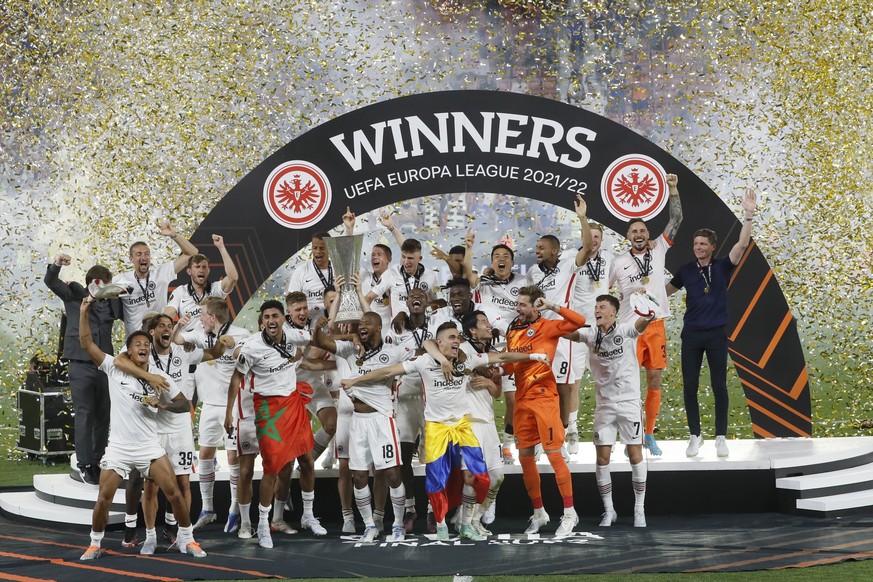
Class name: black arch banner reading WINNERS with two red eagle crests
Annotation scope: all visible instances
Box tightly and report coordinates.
[192,91,812,437]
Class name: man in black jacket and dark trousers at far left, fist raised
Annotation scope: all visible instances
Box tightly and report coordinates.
[44,254,122,485]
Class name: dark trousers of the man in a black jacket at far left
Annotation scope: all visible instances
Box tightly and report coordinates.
[69,362,110,467]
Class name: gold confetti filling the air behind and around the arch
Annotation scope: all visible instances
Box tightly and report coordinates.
[0,0,873,466]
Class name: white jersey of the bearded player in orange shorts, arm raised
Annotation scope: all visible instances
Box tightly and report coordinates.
[609,234,672,323]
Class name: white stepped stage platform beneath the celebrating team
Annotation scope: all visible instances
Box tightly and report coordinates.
[0,437,873,526]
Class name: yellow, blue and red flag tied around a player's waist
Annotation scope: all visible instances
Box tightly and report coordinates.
[424,417,491,522]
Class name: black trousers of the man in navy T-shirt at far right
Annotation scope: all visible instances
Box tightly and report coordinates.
[682,327,728,435]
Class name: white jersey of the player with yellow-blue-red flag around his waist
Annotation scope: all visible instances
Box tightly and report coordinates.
[403,354,488,424]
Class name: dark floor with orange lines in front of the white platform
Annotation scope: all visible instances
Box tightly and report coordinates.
[0,512,873,582]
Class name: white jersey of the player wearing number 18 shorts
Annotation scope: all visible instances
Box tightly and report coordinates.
[336,340,409,418]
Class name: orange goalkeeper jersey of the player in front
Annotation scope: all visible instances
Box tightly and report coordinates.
[504,307,585,399]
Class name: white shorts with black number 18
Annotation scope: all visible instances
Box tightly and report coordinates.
[349,412,401,471]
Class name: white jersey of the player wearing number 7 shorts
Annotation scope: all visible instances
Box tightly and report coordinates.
[579,323,640,404]
